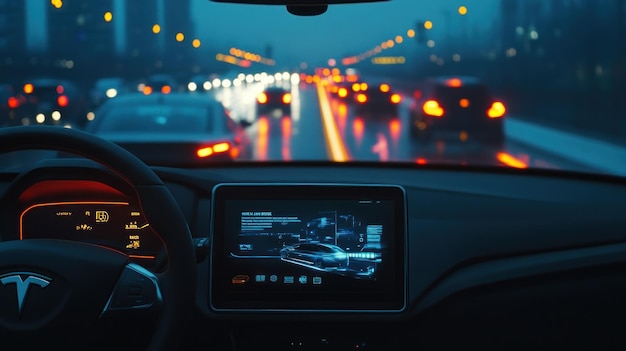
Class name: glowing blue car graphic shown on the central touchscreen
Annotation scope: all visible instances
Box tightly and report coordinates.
[280,243,349,271]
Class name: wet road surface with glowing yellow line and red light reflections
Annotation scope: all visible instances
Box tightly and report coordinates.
[215,80,590,172]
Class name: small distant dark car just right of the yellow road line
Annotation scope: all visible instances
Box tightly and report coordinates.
[352,82,402,117]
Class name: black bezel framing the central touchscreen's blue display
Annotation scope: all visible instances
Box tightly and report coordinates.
[208,183,407,313]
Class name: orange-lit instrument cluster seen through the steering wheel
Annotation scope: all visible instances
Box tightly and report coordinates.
[2,168,165,268]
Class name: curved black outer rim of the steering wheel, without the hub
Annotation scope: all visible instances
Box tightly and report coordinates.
[0,126,196,350]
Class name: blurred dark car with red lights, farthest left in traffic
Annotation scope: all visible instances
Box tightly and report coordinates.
[11,78,86,128]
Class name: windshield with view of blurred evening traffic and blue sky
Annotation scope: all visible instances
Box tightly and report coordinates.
[0,0,626,175]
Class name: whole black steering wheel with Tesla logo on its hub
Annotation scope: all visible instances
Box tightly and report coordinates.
[0,126,196,350]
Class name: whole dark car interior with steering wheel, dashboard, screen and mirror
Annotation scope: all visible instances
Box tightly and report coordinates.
[0,0,626,351]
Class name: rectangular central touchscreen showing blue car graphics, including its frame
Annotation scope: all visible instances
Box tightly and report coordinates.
[211,186,405,311]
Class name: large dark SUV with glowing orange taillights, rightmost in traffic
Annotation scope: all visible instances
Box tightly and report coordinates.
[410,77,506,147]
